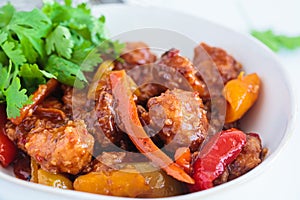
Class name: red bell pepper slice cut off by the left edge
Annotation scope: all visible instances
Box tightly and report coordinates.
[0,104,17,167]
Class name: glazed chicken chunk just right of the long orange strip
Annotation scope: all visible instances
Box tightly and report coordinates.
[148,89,208,152]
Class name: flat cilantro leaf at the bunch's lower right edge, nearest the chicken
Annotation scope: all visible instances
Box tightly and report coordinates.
[45,55,87,88]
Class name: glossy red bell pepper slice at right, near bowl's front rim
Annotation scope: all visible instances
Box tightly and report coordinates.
[189,128,246,192]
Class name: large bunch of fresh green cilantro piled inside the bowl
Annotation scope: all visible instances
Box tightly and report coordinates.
[0,0,124,118]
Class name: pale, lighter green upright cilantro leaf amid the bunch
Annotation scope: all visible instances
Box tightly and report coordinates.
[46,25,74,59]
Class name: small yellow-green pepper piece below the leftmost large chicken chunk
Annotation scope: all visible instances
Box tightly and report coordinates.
[37,169,73,190]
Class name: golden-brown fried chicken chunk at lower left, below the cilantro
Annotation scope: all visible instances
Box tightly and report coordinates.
[25,121,94,174]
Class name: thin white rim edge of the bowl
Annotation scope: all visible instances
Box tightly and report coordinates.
[0,3,299,200]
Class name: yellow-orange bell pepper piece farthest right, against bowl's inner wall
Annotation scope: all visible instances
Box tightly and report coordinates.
[223,72,260,123]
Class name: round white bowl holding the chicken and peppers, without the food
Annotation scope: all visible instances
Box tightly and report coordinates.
[0,5,295,200]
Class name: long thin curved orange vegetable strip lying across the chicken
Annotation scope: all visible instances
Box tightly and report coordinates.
[110,70,194,184]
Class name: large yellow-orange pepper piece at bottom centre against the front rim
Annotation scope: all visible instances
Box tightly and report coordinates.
[74,162,186,198]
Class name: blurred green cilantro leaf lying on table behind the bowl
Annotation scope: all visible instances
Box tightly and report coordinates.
[251,30,300,52]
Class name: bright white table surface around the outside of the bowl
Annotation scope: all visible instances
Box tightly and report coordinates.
[0,0,300,200]
